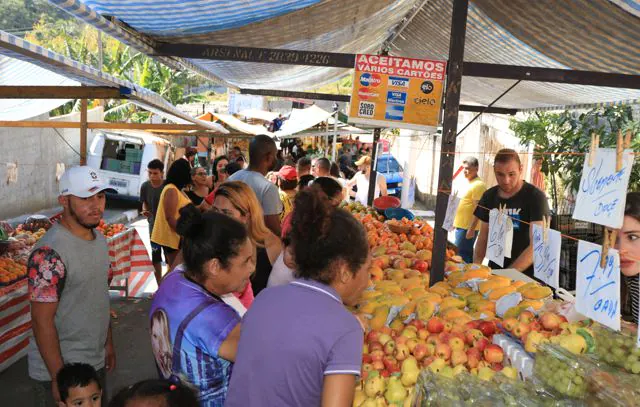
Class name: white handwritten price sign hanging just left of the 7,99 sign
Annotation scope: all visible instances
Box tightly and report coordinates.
[533,224,562,289]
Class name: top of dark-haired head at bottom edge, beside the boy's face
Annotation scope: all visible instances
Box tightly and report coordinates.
[109,379,200,407]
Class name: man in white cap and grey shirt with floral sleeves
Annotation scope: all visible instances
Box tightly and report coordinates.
[27,166,116,406]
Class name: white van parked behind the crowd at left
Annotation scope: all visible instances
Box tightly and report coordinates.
[87,130,173,200]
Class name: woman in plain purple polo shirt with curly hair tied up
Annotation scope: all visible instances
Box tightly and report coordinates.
[225,185,370,407]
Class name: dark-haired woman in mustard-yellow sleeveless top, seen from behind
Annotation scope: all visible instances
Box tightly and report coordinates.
[151,159,191,267]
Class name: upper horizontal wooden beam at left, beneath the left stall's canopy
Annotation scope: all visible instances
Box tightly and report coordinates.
[0,86,131,99]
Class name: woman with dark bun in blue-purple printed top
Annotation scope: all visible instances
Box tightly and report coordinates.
[149,205,255,407]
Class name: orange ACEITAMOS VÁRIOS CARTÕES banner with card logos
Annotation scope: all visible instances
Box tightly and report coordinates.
[349,54,447,130]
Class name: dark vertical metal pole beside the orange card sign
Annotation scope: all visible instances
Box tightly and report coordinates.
[429,0,469,285]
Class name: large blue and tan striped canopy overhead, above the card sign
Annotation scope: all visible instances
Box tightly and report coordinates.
[50,0,640,109]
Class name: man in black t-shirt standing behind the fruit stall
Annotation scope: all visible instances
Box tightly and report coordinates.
[473,149,549,277]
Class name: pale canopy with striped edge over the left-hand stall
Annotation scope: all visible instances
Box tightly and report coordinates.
[0,31,228,134]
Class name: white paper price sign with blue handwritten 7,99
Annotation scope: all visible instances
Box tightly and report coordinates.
[576,240,620,331]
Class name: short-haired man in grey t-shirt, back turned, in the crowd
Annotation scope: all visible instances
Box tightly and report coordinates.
[229,135,283,236]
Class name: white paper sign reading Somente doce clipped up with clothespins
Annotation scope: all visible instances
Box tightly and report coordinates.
[573,148,634,229]
